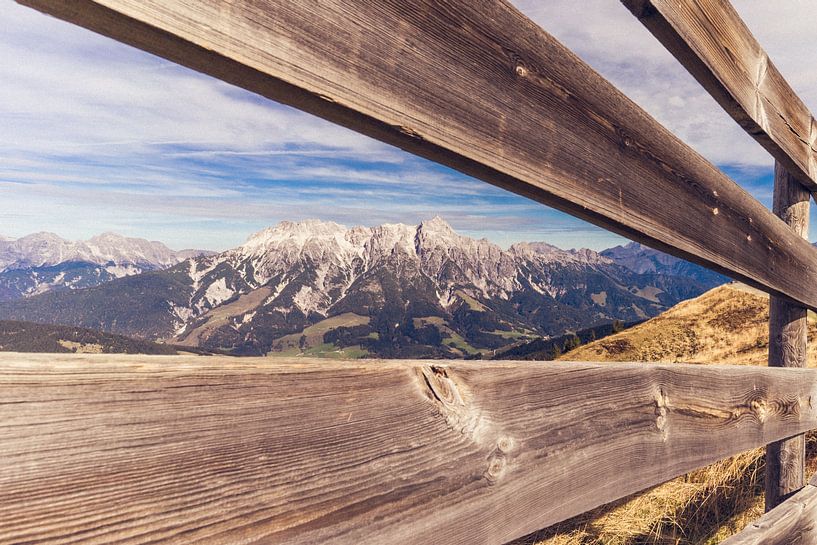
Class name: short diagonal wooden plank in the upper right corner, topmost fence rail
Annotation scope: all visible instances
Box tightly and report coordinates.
[622,0,817,191]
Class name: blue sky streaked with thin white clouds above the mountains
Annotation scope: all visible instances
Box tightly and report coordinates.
[0,0,817,250]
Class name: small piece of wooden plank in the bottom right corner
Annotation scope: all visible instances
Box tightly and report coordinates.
[721,484,817,545]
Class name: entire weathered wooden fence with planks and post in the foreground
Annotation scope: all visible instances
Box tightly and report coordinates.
[0,0,817,544]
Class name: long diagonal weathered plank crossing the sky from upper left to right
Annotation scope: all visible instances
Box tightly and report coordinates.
[14,0,817,309]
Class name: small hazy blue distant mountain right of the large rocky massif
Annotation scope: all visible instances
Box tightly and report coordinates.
[601,242,730,286]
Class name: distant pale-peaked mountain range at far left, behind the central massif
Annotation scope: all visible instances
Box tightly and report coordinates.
[0,233,212,301]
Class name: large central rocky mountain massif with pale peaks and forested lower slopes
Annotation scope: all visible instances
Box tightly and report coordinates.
[0,218,728,357]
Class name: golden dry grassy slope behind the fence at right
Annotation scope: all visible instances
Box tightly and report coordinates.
[517,285,817,545]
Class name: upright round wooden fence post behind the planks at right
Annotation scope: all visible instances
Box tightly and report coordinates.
[766,162,811,511]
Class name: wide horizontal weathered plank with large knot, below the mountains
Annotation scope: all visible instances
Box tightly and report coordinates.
[0,354,817,545]
